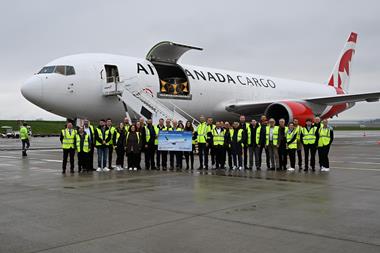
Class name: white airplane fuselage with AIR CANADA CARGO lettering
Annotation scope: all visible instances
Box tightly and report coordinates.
[22,54,336,120]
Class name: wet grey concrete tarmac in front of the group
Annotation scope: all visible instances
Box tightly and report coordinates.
[0,132,380,253]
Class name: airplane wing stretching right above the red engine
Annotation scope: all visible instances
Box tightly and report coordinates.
[226,92,380,115]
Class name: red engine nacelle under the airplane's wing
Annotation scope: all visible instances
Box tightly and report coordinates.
[265,101,314,126]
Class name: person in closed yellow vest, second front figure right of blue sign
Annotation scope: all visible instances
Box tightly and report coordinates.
[211,121,226,170]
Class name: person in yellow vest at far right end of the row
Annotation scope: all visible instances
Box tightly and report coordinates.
[318,119,334,171]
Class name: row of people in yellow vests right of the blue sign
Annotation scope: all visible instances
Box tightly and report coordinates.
[196,115,334,171]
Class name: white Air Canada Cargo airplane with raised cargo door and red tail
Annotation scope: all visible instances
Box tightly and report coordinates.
[21,32,380,124]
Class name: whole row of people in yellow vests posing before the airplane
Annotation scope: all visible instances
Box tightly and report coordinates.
[60,115,334,173]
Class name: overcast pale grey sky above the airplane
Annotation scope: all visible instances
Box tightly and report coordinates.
[0,0,380,119]
